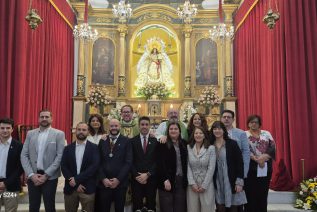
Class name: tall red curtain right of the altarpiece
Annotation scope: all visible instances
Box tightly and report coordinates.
[234,0,317,187]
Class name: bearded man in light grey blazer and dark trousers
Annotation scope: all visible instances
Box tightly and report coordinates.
[21,110,65,212]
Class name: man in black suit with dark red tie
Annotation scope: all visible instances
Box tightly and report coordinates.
[131,116,158,211]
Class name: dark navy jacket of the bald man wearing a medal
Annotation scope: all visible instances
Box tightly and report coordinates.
[98,134,133,187]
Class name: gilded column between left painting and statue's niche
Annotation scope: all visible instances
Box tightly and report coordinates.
[117,24,128,97]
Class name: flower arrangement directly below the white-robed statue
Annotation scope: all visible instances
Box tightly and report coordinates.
[137,82,171,99]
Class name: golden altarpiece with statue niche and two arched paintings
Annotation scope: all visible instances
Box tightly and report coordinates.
[71,0,238,128]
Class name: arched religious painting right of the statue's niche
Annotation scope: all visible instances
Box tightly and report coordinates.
[196,38,218,85]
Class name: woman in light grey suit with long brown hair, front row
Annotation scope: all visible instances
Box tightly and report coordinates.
[187,127,216,212]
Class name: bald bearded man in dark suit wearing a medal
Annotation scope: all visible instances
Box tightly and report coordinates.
[97,119,132,212]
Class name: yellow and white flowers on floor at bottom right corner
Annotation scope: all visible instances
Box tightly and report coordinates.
[295,176,317,210]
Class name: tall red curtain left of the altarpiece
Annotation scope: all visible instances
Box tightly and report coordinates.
[0,0,74,141]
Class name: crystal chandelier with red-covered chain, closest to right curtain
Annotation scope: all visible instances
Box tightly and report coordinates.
[209,0,234,41]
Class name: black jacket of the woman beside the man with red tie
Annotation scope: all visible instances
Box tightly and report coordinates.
[157,140,188,191]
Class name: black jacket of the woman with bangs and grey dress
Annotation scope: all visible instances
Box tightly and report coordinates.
[214,139,244,193]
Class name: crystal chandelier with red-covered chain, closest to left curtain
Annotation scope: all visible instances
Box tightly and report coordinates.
[73,0,98,41]
